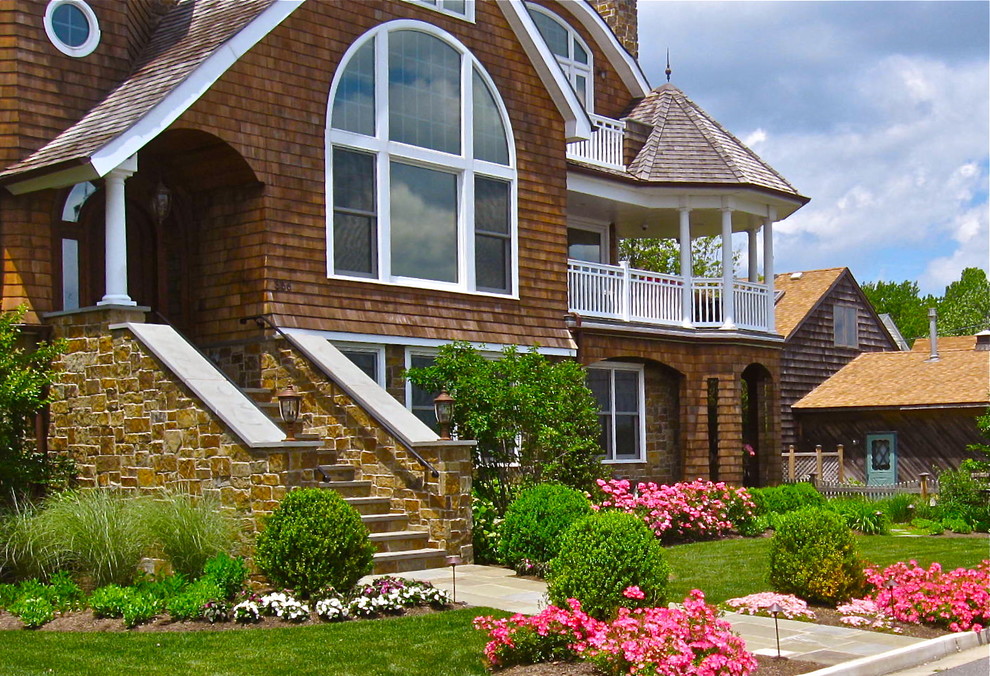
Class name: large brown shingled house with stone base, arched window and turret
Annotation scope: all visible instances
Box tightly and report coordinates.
[0,0,807,566]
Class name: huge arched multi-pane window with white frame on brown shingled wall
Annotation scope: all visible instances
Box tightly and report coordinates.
[327,21,517,294]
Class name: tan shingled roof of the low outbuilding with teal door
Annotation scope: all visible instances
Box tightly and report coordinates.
[792,349,990,411]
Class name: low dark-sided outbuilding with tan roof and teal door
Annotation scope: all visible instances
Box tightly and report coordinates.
[794,332,990,485]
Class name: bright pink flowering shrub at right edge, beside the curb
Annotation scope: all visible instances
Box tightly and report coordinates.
[865,559,990,631]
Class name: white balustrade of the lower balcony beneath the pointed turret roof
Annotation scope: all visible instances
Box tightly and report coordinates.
[567,260,772,332]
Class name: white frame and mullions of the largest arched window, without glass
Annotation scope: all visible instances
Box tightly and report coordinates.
[324,19,519,299]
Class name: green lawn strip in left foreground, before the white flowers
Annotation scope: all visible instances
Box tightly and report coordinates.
[0,608,508,676]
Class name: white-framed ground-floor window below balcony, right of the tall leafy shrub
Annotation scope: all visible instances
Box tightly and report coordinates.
[587,362,646,462]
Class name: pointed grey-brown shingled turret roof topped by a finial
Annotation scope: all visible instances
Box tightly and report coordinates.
[627,84,807,201]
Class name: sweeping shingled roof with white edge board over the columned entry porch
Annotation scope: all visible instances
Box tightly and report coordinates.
[0,0,294,193]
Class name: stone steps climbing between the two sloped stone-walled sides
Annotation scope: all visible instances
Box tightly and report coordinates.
[241,387,446,575]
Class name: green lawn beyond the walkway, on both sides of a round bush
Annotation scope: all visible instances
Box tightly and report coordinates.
[666,535,990,603]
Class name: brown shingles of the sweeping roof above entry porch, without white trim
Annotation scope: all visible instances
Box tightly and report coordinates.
[0,0,275,178]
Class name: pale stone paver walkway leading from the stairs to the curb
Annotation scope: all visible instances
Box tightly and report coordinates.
[382,565,920,667]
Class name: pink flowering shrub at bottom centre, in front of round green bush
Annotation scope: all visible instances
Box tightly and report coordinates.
[474,590,757,676]
